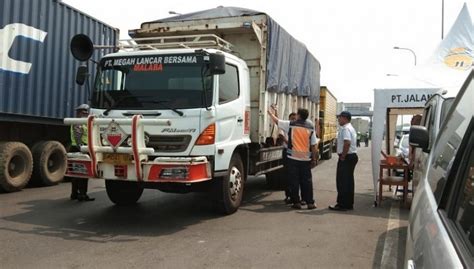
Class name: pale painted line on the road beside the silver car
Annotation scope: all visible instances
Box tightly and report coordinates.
[380,203,400,268]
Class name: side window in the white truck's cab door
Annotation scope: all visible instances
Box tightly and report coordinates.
[219,64,240,104]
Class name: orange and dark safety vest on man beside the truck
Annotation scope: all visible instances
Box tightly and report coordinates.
[287,121,314,161]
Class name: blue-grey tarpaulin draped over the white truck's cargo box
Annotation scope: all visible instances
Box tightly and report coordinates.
[145,7,321,103]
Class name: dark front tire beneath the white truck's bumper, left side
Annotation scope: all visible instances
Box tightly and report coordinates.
[105,180,143,205]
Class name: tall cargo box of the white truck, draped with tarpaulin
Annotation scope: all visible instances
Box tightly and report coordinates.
[129,7,320,143]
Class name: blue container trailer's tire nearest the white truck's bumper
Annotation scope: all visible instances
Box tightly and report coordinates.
[31,141,67,186]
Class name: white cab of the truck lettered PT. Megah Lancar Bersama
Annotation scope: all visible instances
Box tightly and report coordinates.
[68,43,250,213]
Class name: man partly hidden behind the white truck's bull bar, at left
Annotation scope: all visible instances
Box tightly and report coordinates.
[71,104,95,201]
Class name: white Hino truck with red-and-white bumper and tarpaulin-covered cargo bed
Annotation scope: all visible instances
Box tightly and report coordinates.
[65,7,320,214]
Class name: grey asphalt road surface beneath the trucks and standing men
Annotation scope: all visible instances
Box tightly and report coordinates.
[0,144,408,268]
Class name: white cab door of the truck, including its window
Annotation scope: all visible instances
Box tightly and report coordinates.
[216,64,244,170]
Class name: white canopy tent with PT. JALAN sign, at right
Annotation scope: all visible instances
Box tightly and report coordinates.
[372,4,474,204]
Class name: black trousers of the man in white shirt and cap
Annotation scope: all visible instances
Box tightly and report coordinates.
[336,153,359,208]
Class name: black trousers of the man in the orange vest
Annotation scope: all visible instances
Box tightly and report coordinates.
[286,158,314,204]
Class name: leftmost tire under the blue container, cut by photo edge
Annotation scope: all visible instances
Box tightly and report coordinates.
[0,142,33,192]
